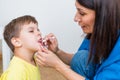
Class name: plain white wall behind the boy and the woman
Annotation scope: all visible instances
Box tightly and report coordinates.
[0,0,82,70]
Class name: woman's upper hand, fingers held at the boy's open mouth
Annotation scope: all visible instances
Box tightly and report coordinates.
[44,33,59,53]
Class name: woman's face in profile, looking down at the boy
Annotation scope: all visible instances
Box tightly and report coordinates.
[74,1,95,34]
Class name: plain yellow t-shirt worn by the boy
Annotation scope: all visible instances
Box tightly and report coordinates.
[1,56,41,80]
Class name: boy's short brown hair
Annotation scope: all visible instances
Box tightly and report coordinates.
[3,15,38,52]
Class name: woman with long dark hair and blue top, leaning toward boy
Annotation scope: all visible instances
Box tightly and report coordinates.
[37,0,120,80]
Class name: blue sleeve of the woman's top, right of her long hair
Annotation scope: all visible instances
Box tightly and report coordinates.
[95,37,120,80]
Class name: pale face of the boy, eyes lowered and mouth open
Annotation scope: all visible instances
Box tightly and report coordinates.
[19,23,42,52]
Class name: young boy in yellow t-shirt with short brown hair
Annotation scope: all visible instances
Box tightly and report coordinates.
[1,15,42,80]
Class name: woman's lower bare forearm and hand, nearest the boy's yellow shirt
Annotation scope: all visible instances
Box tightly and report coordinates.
[36,49,85,80]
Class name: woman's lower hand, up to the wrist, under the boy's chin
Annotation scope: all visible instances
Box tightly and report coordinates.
[36,48,63,68]
